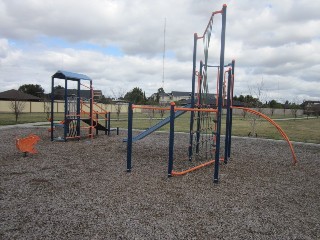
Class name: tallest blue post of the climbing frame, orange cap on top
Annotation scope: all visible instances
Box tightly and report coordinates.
[213,4,227,183]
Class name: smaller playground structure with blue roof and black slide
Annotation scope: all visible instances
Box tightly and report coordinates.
[49,71,111,141]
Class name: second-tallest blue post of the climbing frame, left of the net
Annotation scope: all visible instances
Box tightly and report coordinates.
[189,33,198,161]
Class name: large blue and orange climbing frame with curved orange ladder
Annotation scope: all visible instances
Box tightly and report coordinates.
[124,5,297,183]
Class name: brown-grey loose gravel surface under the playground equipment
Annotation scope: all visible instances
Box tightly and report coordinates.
[0,127,320,240]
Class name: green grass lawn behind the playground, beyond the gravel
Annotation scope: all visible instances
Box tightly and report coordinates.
[0,113,320,144]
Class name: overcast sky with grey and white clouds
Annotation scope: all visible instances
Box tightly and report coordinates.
[0,0,320,102]
